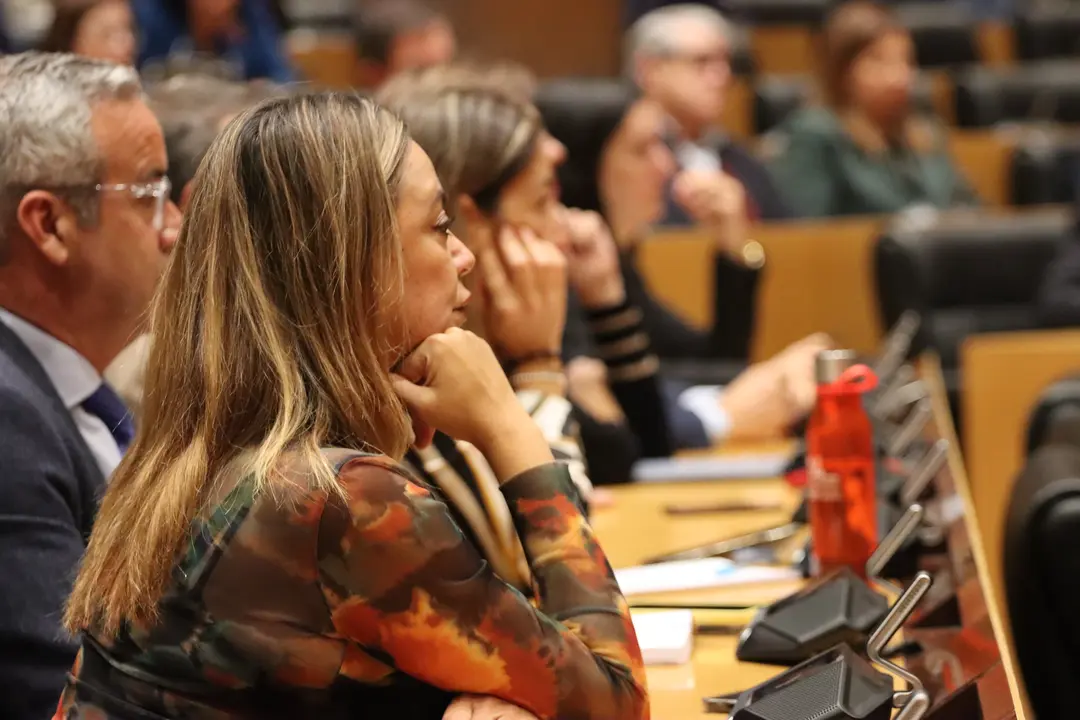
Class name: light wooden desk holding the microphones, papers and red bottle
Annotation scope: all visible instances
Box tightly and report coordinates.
[592,357,1030,720]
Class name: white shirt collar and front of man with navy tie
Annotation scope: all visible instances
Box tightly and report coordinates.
[0,308,120,479]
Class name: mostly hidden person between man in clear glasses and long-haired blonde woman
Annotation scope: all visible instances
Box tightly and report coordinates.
[105,76,284,422]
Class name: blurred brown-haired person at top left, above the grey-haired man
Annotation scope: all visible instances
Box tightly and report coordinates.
[41,0,136,65]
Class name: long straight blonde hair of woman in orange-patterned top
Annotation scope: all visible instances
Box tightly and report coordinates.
[65,93,411,636]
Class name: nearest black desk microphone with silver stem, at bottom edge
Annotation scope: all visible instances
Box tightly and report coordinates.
[705,572,932,720]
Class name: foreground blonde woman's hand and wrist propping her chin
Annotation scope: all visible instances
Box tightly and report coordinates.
[393,327,552,481]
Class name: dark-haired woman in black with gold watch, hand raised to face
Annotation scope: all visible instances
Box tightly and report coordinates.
[537,83,765,361]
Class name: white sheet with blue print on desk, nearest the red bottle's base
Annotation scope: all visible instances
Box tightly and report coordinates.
[615,557,801,595]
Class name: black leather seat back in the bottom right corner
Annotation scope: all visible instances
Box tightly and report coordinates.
[1006,444,1080,718]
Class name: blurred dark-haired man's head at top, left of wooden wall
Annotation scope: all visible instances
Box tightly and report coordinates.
[355,0,457,87]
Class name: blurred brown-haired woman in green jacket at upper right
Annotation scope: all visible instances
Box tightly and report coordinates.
[772,0,977,217]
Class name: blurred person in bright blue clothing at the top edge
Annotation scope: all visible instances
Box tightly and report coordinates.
[132,0,296,82]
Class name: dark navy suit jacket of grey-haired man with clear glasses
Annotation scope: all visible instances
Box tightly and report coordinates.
[0,323,105,720]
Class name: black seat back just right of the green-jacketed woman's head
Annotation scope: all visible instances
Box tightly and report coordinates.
[895,2,978,68]
